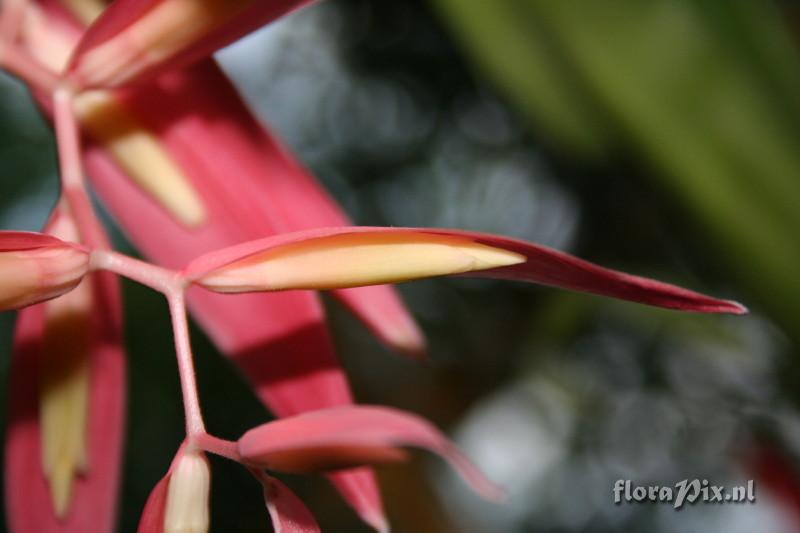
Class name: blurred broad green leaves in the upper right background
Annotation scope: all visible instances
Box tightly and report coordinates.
[434,0,800,336]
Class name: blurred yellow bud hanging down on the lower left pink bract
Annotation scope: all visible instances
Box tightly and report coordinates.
[39,281,92,516]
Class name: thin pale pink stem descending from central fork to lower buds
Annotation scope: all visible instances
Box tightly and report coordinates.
[167,289,206,436]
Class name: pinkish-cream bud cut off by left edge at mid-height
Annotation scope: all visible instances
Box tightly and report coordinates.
[0,245,89,311]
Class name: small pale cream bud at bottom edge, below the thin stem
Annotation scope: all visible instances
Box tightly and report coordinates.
[164,452,211,533]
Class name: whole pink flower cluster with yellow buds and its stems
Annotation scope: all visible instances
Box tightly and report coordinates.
[0,0,745,533]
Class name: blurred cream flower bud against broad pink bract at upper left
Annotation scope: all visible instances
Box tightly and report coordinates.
[75,91,206,227]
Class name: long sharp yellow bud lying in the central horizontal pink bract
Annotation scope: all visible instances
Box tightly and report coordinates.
[197,232,525,292]
